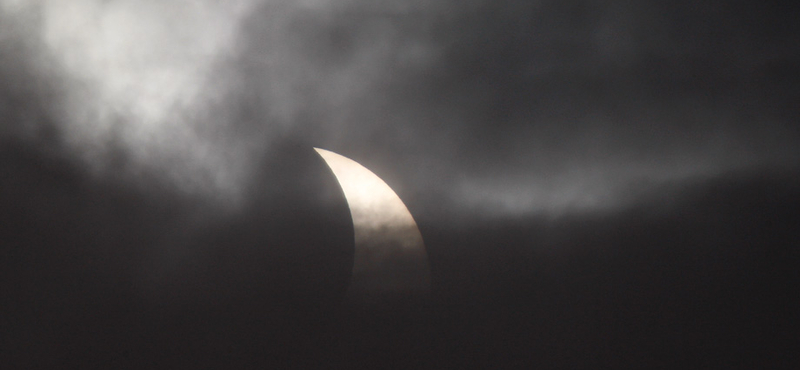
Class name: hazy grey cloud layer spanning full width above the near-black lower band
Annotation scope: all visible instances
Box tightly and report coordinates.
[3,0,798,214]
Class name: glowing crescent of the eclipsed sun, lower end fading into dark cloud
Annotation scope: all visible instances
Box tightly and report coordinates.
[314,148,430,298]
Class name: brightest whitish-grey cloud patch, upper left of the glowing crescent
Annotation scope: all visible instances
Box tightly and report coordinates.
[4,0,260,207]
